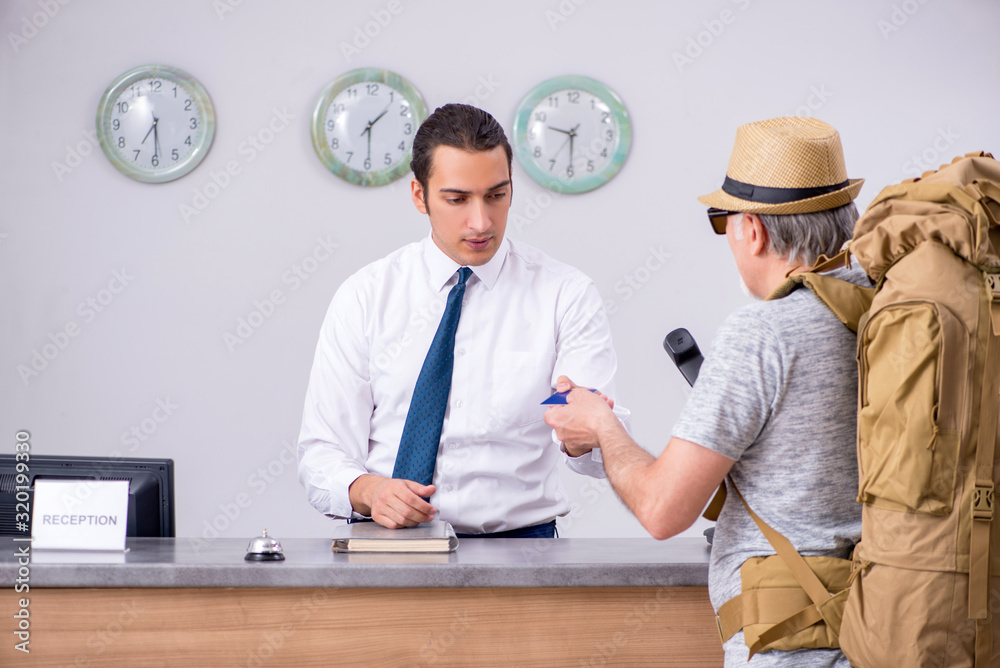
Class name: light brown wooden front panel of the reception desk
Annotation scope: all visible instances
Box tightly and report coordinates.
[0,587,722,668]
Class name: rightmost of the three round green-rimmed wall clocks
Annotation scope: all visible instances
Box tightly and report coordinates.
[514,75,632,193]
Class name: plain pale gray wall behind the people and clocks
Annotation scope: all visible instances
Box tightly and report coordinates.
[0,0,1000,537]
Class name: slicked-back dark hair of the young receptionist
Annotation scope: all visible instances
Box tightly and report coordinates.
[410,104,513,196]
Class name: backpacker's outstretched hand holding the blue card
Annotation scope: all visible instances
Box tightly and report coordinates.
[545,376,622,457]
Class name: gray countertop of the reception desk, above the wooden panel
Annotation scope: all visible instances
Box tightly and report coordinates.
[0,536,709,587]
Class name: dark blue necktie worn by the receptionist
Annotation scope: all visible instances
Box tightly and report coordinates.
[392,267,472,485]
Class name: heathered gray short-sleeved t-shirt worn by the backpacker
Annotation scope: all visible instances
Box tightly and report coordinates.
[673,268,868,668]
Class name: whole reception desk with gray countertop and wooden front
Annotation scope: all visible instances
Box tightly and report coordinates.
[0,536,722,667]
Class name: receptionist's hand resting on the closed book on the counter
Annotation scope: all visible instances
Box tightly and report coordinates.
[349,474,437,529]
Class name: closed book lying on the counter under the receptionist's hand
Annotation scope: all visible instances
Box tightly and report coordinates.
[333,520,458,552]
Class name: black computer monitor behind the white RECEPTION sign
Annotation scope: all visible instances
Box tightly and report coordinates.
[0,454,174,538]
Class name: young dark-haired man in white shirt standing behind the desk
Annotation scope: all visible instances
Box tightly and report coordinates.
[298,104,628,537]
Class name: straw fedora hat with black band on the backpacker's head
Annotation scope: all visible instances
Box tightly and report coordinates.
[698,116,865,214]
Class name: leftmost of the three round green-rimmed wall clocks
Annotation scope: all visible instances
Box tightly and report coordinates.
[97,65,215,183]
